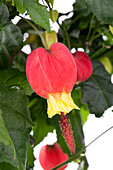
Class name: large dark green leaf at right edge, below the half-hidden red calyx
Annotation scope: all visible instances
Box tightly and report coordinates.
[81,61,113,117]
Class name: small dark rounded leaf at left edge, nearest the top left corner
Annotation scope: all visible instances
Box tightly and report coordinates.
[0,4,9,27]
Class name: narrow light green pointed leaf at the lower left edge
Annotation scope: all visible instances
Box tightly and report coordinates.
[0,109,15,157]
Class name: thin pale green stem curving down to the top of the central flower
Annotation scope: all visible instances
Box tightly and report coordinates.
[19,15,48,49]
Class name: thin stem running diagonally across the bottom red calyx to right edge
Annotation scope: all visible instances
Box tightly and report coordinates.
[52,126,113,170]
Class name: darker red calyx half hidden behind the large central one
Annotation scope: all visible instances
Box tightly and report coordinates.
[73,51,93,82]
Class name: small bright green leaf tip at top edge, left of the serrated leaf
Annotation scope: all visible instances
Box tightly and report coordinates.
[14,0,26,14]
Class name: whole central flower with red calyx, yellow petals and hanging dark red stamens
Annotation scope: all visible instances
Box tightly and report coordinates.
[26,42,79,153]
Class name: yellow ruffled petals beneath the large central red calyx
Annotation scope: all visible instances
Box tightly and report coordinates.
[47,91,79,118]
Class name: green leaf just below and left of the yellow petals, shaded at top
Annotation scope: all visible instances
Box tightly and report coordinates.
[29,96,54,145]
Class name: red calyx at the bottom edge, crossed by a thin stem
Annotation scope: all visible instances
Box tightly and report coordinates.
[39,143,69,170]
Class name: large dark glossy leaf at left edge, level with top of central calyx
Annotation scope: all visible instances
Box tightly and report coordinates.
[0,22,23,69]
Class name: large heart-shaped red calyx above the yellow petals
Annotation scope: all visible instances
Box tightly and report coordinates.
[26,42,77,99]
